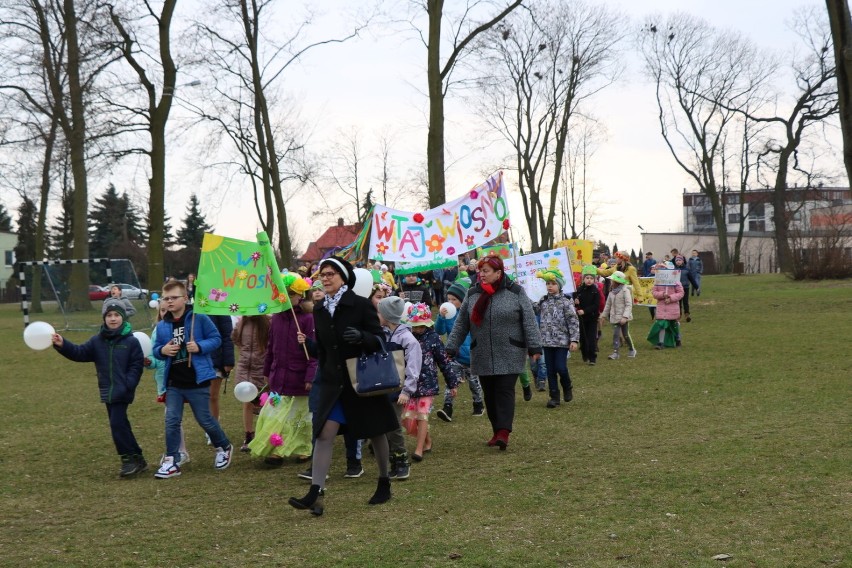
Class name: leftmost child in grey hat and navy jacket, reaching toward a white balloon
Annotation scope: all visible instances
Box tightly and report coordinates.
[51,301,148,477]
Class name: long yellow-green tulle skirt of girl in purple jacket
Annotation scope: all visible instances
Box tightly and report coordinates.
[248,395,312,458]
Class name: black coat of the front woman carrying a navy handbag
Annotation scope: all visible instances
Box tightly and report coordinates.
[314,290,399,438]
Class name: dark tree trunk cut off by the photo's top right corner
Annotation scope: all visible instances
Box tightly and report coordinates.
[825,0,852,185]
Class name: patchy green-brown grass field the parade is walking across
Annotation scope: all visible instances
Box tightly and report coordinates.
[0,275,852,567]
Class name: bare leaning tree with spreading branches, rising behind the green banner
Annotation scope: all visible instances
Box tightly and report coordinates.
[194,0,364,266]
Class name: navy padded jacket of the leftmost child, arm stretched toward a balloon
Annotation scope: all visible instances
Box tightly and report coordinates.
[54,323,145,404]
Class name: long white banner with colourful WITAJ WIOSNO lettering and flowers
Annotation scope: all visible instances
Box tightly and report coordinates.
[366,172,509,262]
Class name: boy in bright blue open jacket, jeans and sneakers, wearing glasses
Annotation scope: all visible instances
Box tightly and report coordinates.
[152,280,234,479]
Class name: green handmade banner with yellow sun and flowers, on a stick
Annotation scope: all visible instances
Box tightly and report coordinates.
[194,232,292,316]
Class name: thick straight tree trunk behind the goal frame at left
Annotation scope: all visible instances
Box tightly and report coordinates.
[64,0,92,310]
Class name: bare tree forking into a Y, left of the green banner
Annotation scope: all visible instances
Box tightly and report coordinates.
[107,0,177,283]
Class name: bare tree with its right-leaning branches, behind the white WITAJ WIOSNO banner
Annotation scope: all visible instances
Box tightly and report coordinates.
[418,0,522,207]
